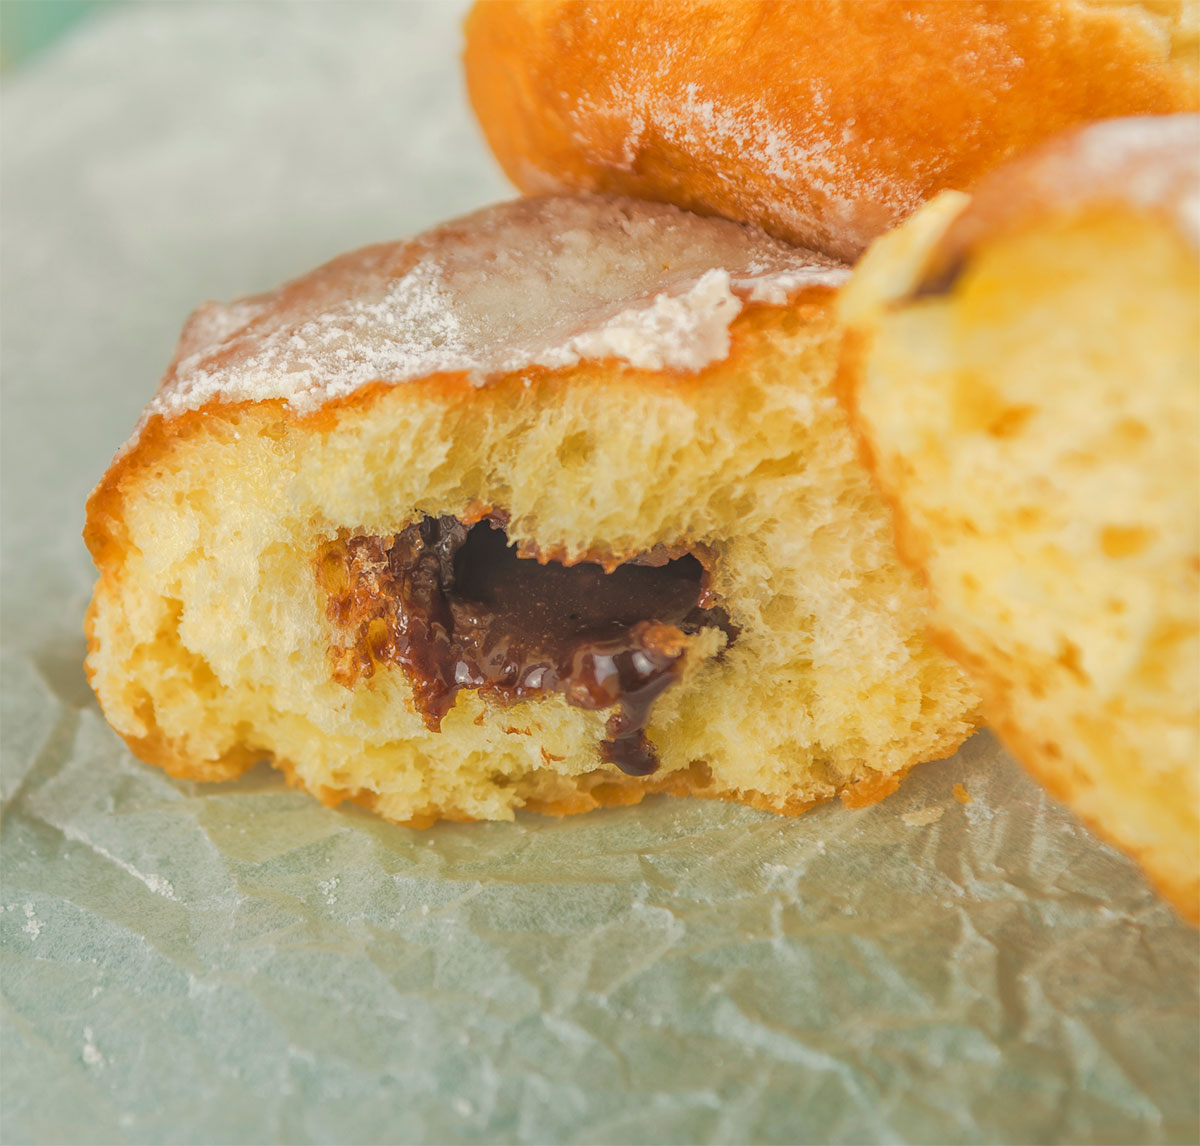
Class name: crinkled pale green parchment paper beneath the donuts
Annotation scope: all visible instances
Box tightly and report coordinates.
[0,4,1200,1144]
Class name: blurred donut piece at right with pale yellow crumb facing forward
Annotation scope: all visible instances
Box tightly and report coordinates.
[844,115,1200,919]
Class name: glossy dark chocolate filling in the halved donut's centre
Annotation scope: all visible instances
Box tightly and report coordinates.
[320,517,734,775]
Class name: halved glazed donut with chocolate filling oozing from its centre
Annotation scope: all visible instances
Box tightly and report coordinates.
[85,197,977,824]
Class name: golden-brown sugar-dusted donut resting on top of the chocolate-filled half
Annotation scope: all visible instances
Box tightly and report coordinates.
[464,0,1200,259]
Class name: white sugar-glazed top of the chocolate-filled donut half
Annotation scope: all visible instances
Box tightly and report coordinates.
[143,196,848,424]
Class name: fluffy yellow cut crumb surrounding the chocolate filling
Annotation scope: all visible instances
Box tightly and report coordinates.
[89,300,976,824]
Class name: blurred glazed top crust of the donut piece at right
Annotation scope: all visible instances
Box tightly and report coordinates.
[922,115,1200,293]
